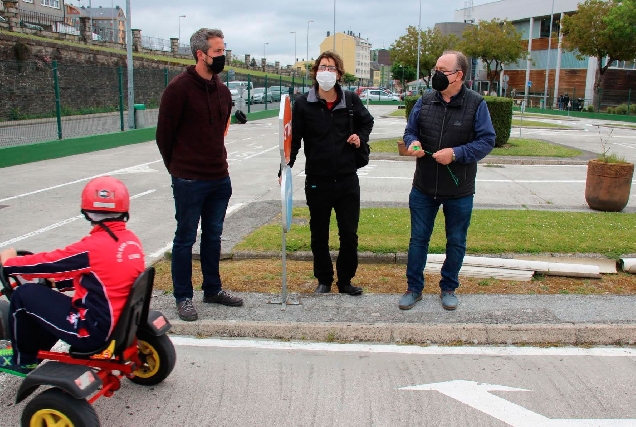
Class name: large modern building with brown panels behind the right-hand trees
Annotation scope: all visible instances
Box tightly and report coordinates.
[454,0,636,107]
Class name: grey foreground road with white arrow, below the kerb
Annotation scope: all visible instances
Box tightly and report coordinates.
[0,337,636,427]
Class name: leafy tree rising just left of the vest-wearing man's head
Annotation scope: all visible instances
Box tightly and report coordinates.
[391,25,458,85]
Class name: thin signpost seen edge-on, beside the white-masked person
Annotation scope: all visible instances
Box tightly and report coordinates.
[270,95,299,310]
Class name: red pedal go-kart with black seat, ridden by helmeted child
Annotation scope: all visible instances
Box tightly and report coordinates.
[0,251,176,427]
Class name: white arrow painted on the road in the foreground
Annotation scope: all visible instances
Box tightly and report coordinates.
[400,380,636,427]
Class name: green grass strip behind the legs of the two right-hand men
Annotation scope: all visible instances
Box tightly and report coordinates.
[235,207,636,258]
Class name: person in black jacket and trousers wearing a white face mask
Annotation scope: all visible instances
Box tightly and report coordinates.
[289,52,373,295]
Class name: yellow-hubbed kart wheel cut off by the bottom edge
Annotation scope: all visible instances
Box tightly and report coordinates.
[21,388,99,427]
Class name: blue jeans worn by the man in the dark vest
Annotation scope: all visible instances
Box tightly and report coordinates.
[406,187,473,293]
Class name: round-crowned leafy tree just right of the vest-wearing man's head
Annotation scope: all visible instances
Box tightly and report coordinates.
[460,18,526,91]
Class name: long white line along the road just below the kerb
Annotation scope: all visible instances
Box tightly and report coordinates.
[170,335,636,357]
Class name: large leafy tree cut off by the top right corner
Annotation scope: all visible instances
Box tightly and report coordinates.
[562,0,636,104]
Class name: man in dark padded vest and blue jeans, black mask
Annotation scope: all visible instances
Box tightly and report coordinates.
[399,51,495,310]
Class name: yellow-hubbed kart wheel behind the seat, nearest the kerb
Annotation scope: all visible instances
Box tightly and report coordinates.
[130,330,177,386]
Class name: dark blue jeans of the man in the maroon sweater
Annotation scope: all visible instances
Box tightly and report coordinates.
[172,177,232,302]
